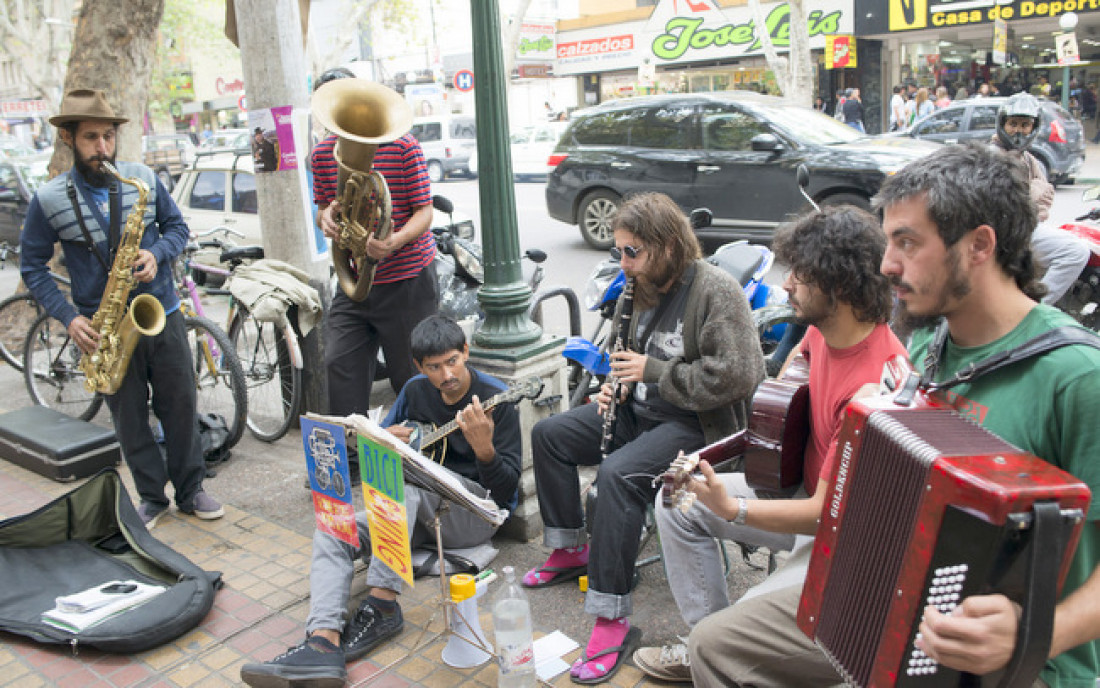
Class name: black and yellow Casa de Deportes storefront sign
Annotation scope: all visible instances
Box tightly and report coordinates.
[856,0,1100,36]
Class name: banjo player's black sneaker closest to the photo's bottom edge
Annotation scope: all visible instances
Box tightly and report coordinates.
[241,635,348,688]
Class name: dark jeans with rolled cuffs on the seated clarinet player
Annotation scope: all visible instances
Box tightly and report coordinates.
[531,404,704,619]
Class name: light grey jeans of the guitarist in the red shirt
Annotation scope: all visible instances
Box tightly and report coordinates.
[655,473,806,626]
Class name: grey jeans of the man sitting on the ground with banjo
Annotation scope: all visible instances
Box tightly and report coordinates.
[306,476,496,634]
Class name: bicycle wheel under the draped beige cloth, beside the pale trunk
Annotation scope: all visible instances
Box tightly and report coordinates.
[229,307,301,441]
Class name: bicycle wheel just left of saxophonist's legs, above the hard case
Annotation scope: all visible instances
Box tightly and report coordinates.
[23,314,103,421]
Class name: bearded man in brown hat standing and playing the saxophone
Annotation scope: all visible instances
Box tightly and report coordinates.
[20,89,224,528]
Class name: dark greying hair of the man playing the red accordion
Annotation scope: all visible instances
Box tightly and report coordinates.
[872,143,1046,299]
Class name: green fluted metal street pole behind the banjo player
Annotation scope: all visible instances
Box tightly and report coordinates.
[470,0,542,349]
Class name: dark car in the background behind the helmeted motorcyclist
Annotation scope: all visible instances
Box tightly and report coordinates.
[888,98,1086,184]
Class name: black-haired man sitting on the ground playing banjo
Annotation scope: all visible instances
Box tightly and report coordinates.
[241,315,523,686]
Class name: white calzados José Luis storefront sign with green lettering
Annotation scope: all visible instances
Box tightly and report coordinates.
[554,0,849,76]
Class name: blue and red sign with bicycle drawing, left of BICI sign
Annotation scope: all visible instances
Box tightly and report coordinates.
[301,416,360,548]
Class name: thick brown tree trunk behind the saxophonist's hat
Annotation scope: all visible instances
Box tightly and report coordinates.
[50,0,164,175]
